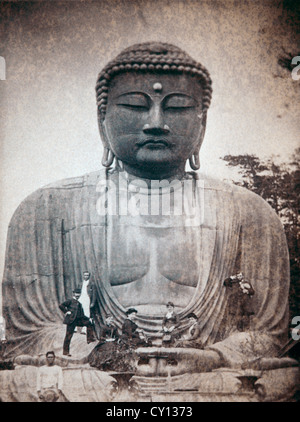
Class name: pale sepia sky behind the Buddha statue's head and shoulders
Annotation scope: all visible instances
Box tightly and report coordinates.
[0,0,300,310]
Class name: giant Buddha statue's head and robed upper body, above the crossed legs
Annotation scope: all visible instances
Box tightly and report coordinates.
[3,43,296,400]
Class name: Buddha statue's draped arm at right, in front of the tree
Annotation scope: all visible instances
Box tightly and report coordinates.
[207,193,289,366]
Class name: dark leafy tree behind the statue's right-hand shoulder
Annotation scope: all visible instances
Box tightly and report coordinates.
[222,148,300,330]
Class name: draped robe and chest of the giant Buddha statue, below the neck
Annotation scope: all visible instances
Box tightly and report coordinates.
[3,171,289,366]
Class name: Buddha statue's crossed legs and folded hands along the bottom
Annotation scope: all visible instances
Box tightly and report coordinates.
[0,344,300,402]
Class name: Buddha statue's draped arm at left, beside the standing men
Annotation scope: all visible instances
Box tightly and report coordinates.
[2,190,66,354]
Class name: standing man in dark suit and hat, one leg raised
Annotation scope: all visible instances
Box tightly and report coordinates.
[59,289,95,356]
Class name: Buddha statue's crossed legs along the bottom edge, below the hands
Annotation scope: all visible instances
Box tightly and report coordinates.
[0,365,299,402]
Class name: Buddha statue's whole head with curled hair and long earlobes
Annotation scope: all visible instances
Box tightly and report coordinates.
[96,42,212,179]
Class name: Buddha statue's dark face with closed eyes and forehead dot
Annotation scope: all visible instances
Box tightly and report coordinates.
[103,72,203,175]
